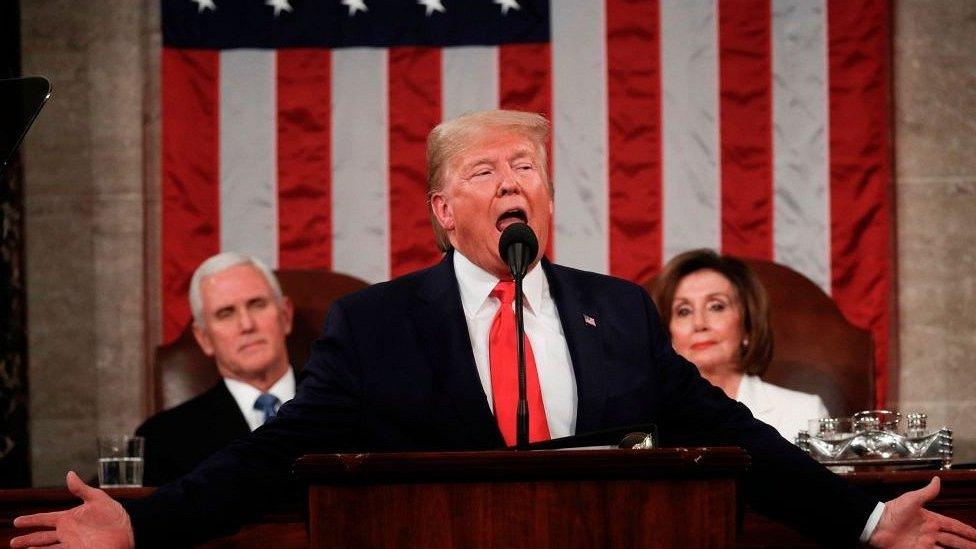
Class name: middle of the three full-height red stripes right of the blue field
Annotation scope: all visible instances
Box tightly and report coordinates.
[718,0,773,260]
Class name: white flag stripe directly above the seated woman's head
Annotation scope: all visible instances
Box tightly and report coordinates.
[660,0,721,261]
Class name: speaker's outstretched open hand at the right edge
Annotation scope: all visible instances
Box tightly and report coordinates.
[869,477,976,548]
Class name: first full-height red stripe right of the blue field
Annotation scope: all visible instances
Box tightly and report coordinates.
[606,0,662,282]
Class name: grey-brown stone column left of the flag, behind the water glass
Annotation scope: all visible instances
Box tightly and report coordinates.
[21,0,158,486]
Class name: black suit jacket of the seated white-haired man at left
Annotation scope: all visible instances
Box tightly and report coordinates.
[136,380,251,486]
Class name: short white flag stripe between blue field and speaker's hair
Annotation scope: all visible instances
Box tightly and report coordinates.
[441,46,498,120]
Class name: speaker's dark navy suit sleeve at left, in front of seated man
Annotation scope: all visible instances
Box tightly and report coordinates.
[125,303,360,547]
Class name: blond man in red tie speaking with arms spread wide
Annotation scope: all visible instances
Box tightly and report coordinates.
[11,111,976,547]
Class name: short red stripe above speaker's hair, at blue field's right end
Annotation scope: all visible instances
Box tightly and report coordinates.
[498,44,556,259]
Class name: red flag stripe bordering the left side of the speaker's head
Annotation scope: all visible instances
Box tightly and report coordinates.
[389,47,441,277]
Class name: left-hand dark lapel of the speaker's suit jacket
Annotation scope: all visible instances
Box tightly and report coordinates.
[410,253,505,446]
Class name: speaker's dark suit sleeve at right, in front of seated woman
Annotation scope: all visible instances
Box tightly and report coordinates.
[641,292,878,546]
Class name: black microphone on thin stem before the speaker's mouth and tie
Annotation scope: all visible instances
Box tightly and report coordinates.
[498,223,539,450]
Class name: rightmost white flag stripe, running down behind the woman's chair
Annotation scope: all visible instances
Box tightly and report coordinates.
[772,0,830,294]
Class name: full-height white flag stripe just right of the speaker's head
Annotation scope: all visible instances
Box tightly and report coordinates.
[550,0,609,273]
